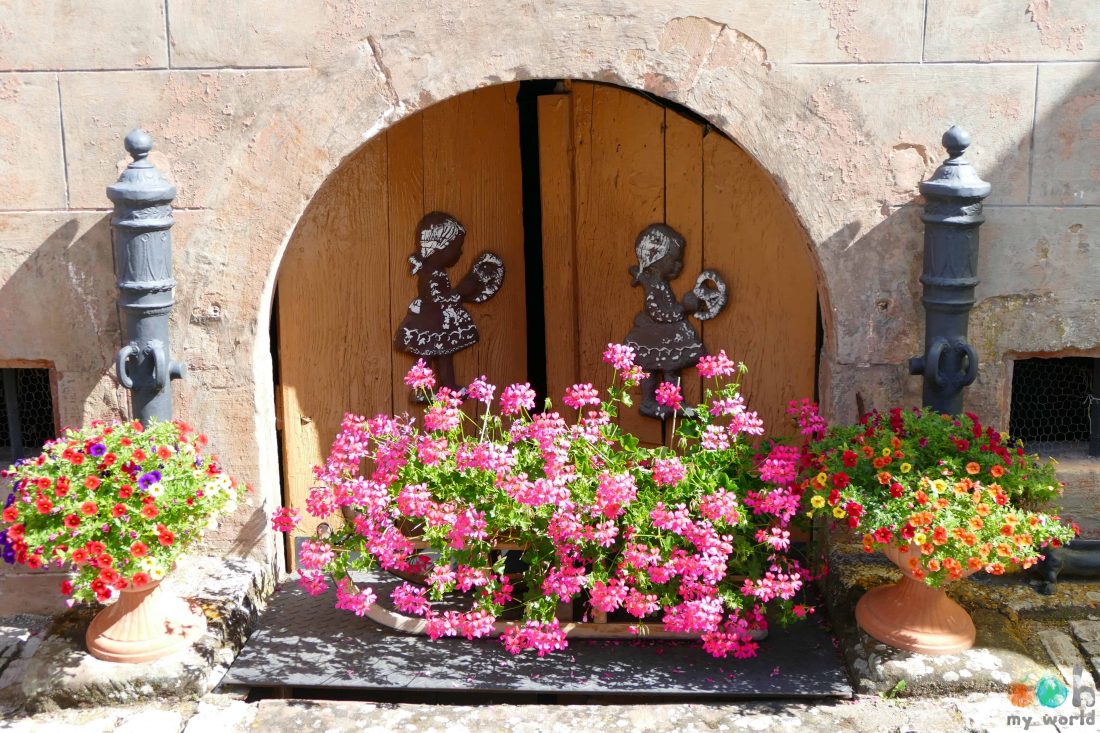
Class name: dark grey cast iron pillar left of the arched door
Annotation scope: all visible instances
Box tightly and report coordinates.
[107,130,184,425]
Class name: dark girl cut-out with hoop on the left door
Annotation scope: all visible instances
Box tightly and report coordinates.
[394,211,504,391]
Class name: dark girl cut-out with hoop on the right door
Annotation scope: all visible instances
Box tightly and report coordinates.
[625,225,727,419]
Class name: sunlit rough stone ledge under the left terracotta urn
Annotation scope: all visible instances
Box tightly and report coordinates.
[11,557,274,713]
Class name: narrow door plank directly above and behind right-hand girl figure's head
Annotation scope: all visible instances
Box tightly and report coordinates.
[664,109,704,420]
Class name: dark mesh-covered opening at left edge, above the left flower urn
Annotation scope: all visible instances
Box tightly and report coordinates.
[0,369,57,463]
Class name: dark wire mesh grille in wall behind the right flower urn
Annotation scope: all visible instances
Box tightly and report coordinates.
[1009,357,1097,448]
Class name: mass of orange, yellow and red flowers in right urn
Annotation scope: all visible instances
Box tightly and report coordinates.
[803,402,1074,586]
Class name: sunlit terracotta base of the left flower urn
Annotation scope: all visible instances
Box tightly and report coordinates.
[85,581,206,664]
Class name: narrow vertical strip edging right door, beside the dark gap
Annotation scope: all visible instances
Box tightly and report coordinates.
[538,95,581,404]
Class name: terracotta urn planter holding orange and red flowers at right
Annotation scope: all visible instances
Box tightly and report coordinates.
[856,546,976,654]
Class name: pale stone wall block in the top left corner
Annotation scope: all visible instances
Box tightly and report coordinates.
[0,0,168,70]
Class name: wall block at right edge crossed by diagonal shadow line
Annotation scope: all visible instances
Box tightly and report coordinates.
[1031,63,1100,204]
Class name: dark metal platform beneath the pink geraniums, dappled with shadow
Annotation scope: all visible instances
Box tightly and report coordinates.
[223,577,853,699]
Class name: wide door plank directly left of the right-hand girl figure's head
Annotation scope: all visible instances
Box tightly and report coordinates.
[573,83,664,444]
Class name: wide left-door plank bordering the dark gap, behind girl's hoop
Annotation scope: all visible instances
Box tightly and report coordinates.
[424,84,527,396]
